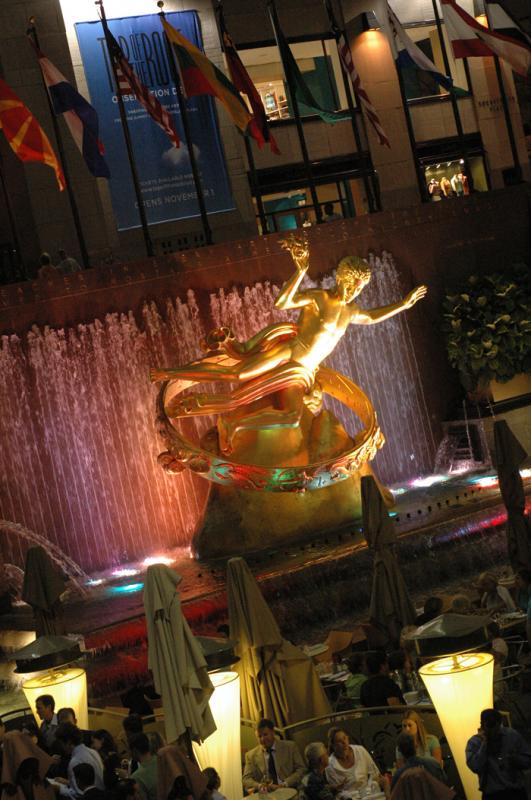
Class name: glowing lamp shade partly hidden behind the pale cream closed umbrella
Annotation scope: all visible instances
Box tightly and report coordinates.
[194,672,243,800]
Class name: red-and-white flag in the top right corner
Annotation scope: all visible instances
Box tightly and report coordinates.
[441,0,531,78]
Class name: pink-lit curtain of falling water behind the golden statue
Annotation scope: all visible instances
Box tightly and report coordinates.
[0,247,436,571]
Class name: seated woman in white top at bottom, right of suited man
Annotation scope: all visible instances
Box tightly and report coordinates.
[325,728,387,795]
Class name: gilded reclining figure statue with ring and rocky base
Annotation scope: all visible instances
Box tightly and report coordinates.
[151,234,426,557]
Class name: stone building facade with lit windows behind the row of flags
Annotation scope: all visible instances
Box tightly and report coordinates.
[0,0,529,282]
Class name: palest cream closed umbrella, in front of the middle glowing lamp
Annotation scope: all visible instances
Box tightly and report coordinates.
[144,564,216,743]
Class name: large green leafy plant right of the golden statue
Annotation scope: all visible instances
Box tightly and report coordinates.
[444,264,531,391]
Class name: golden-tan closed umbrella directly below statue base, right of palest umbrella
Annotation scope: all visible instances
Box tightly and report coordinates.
[227,558,330,726]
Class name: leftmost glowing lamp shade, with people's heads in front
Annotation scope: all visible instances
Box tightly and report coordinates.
[22,667,88,730]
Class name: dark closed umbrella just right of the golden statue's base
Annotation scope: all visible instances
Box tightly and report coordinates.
[361,475,415,640]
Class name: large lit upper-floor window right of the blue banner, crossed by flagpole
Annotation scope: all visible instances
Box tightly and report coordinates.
[238,39,354,120]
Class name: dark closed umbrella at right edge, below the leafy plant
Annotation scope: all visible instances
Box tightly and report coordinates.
[494,419,531,570]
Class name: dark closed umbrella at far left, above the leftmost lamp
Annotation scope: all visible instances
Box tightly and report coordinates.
[22,547,66,636]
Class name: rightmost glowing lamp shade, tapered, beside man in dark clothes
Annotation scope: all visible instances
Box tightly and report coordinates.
[419,653,494,800]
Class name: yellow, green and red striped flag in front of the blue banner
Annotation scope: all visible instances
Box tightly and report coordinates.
[162,17,252,133]
